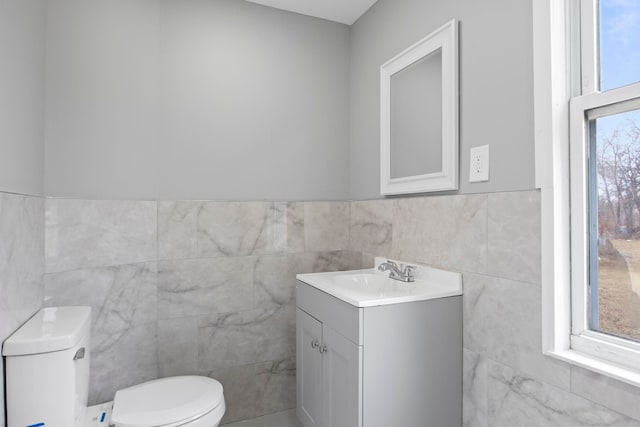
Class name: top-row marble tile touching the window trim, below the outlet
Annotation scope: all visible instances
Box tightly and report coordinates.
[487,191,541,284]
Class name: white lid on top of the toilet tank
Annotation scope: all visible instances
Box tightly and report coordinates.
[2,307,91,356]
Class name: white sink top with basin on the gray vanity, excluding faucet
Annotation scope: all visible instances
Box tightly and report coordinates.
[296,258,462,307]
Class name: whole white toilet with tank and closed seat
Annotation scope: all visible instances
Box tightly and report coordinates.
[2,307,225,427]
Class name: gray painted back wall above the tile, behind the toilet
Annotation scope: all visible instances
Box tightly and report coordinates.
[45,0,349,200]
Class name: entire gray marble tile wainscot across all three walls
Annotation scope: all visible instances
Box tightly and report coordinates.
[0,191,640,427]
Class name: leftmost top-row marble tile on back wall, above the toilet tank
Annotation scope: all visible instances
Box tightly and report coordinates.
[46,199,157,273]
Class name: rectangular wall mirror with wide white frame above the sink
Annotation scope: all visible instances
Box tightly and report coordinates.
[380,20,458,195]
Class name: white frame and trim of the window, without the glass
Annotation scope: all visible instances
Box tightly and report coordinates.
[533,0,640,386]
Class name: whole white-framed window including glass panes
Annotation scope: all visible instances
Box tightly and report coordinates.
[534,0,640,385]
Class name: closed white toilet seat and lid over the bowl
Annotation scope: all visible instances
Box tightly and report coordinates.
[111,376,224,427]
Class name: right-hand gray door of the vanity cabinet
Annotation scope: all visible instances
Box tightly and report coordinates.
[322,325,362,427]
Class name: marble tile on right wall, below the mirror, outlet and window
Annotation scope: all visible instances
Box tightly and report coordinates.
[349,191,640,427]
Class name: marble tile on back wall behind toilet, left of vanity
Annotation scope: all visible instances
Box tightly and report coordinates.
[44,199,361,422]
